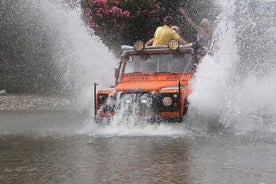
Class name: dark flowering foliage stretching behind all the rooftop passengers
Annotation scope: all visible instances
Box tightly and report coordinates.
[81,0,218,53]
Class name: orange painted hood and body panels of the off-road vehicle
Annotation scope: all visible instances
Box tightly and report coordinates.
[95,44,194,121]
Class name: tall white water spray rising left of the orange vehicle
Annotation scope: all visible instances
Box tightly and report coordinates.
[15,0,117,109]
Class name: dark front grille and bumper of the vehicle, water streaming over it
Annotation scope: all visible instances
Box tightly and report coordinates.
[96,92,187,118]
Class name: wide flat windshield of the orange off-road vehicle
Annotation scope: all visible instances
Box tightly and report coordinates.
[124,54,192,74]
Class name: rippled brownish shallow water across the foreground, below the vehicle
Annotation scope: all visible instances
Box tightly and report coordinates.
[0,112,276,184]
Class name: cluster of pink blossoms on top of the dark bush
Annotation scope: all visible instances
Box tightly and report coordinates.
[83,0,164,30]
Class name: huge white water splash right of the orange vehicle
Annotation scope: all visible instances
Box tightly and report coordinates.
[189,0,276,132]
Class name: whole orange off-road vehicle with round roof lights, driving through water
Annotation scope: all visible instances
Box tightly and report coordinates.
[94,40,194,122]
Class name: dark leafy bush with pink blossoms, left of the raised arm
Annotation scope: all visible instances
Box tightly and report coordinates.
[81,0,166,54]
